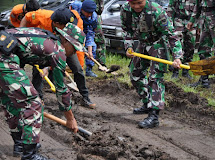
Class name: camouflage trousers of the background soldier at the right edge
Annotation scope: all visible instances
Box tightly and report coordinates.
[198,11,215,59]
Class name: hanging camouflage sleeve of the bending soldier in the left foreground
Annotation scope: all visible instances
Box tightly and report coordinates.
[44,42,72,111]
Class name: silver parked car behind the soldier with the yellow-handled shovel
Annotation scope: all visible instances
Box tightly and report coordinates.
[102,0,169,54]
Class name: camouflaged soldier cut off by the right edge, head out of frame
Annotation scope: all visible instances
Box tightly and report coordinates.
[187,0,215,88]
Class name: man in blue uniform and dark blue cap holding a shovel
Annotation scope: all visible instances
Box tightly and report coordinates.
[70,0,97,77]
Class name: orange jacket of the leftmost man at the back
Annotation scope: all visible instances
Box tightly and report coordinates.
[10,4,25,27]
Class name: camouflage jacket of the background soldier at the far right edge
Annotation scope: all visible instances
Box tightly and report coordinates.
[190,0,215,23]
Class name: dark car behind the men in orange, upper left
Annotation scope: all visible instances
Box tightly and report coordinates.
[0,0,71,28]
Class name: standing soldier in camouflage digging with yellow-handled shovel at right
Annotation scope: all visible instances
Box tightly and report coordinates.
[121,0,183,128]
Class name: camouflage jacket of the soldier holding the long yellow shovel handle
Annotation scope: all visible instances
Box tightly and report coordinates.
[120,1,183,58]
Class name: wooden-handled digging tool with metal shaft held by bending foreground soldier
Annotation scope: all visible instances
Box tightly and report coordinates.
[43,112,92,136]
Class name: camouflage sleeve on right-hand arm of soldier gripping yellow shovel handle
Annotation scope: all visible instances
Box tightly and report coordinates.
[155,11,183,59]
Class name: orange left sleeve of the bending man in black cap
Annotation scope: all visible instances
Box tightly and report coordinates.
[25,11,40,27]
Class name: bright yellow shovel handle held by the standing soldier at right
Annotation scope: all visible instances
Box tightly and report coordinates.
[128,50,190,69]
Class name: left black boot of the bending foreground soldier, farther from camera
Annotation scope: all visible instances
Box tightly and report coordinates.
[10,132,23,157]
